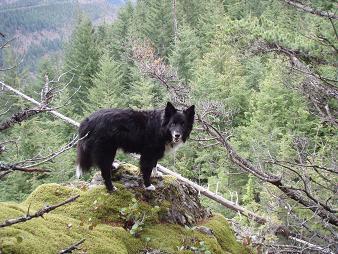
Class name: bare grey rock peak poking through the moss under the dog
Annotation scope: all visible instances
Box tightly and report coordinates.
[90,164,211,225]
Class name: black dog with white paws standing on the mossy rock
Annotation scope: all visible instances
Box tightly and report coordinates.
[76,102,195,192]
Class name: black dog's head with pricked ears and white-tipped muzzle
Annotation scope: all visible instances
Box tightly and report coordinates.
[163,102,195,143]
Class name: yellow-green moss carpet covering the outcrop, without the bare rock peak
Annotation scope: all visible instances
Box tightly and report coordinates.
[0,164,247,254]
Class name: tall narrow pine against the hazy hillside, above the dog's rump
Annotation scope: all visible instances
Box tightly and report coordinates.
[65,15,99,115]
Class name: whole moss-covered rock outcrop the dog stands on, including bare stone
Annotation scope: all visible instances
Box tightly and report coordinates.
[0,165,248,254]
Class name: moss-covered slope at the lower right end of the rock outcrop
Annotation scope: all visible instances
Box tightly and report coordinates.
[203,214,250,254]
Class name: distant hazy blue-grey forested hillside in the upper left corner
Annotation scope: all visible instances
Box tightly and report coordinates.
[0,0,123,73]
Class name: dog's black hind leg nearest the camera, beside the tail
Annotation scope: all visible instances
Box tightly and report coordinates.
[95,149,116,193]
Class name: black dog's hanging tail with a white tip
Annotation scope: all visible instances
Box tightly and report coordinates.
[76,123,93,179]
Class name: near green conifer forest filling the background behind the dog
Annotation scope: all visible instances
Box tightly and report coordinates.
[0,0,338,253]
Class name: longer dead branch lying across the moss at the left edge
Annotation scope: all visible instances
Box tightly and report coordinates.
[0,195,80,228]
